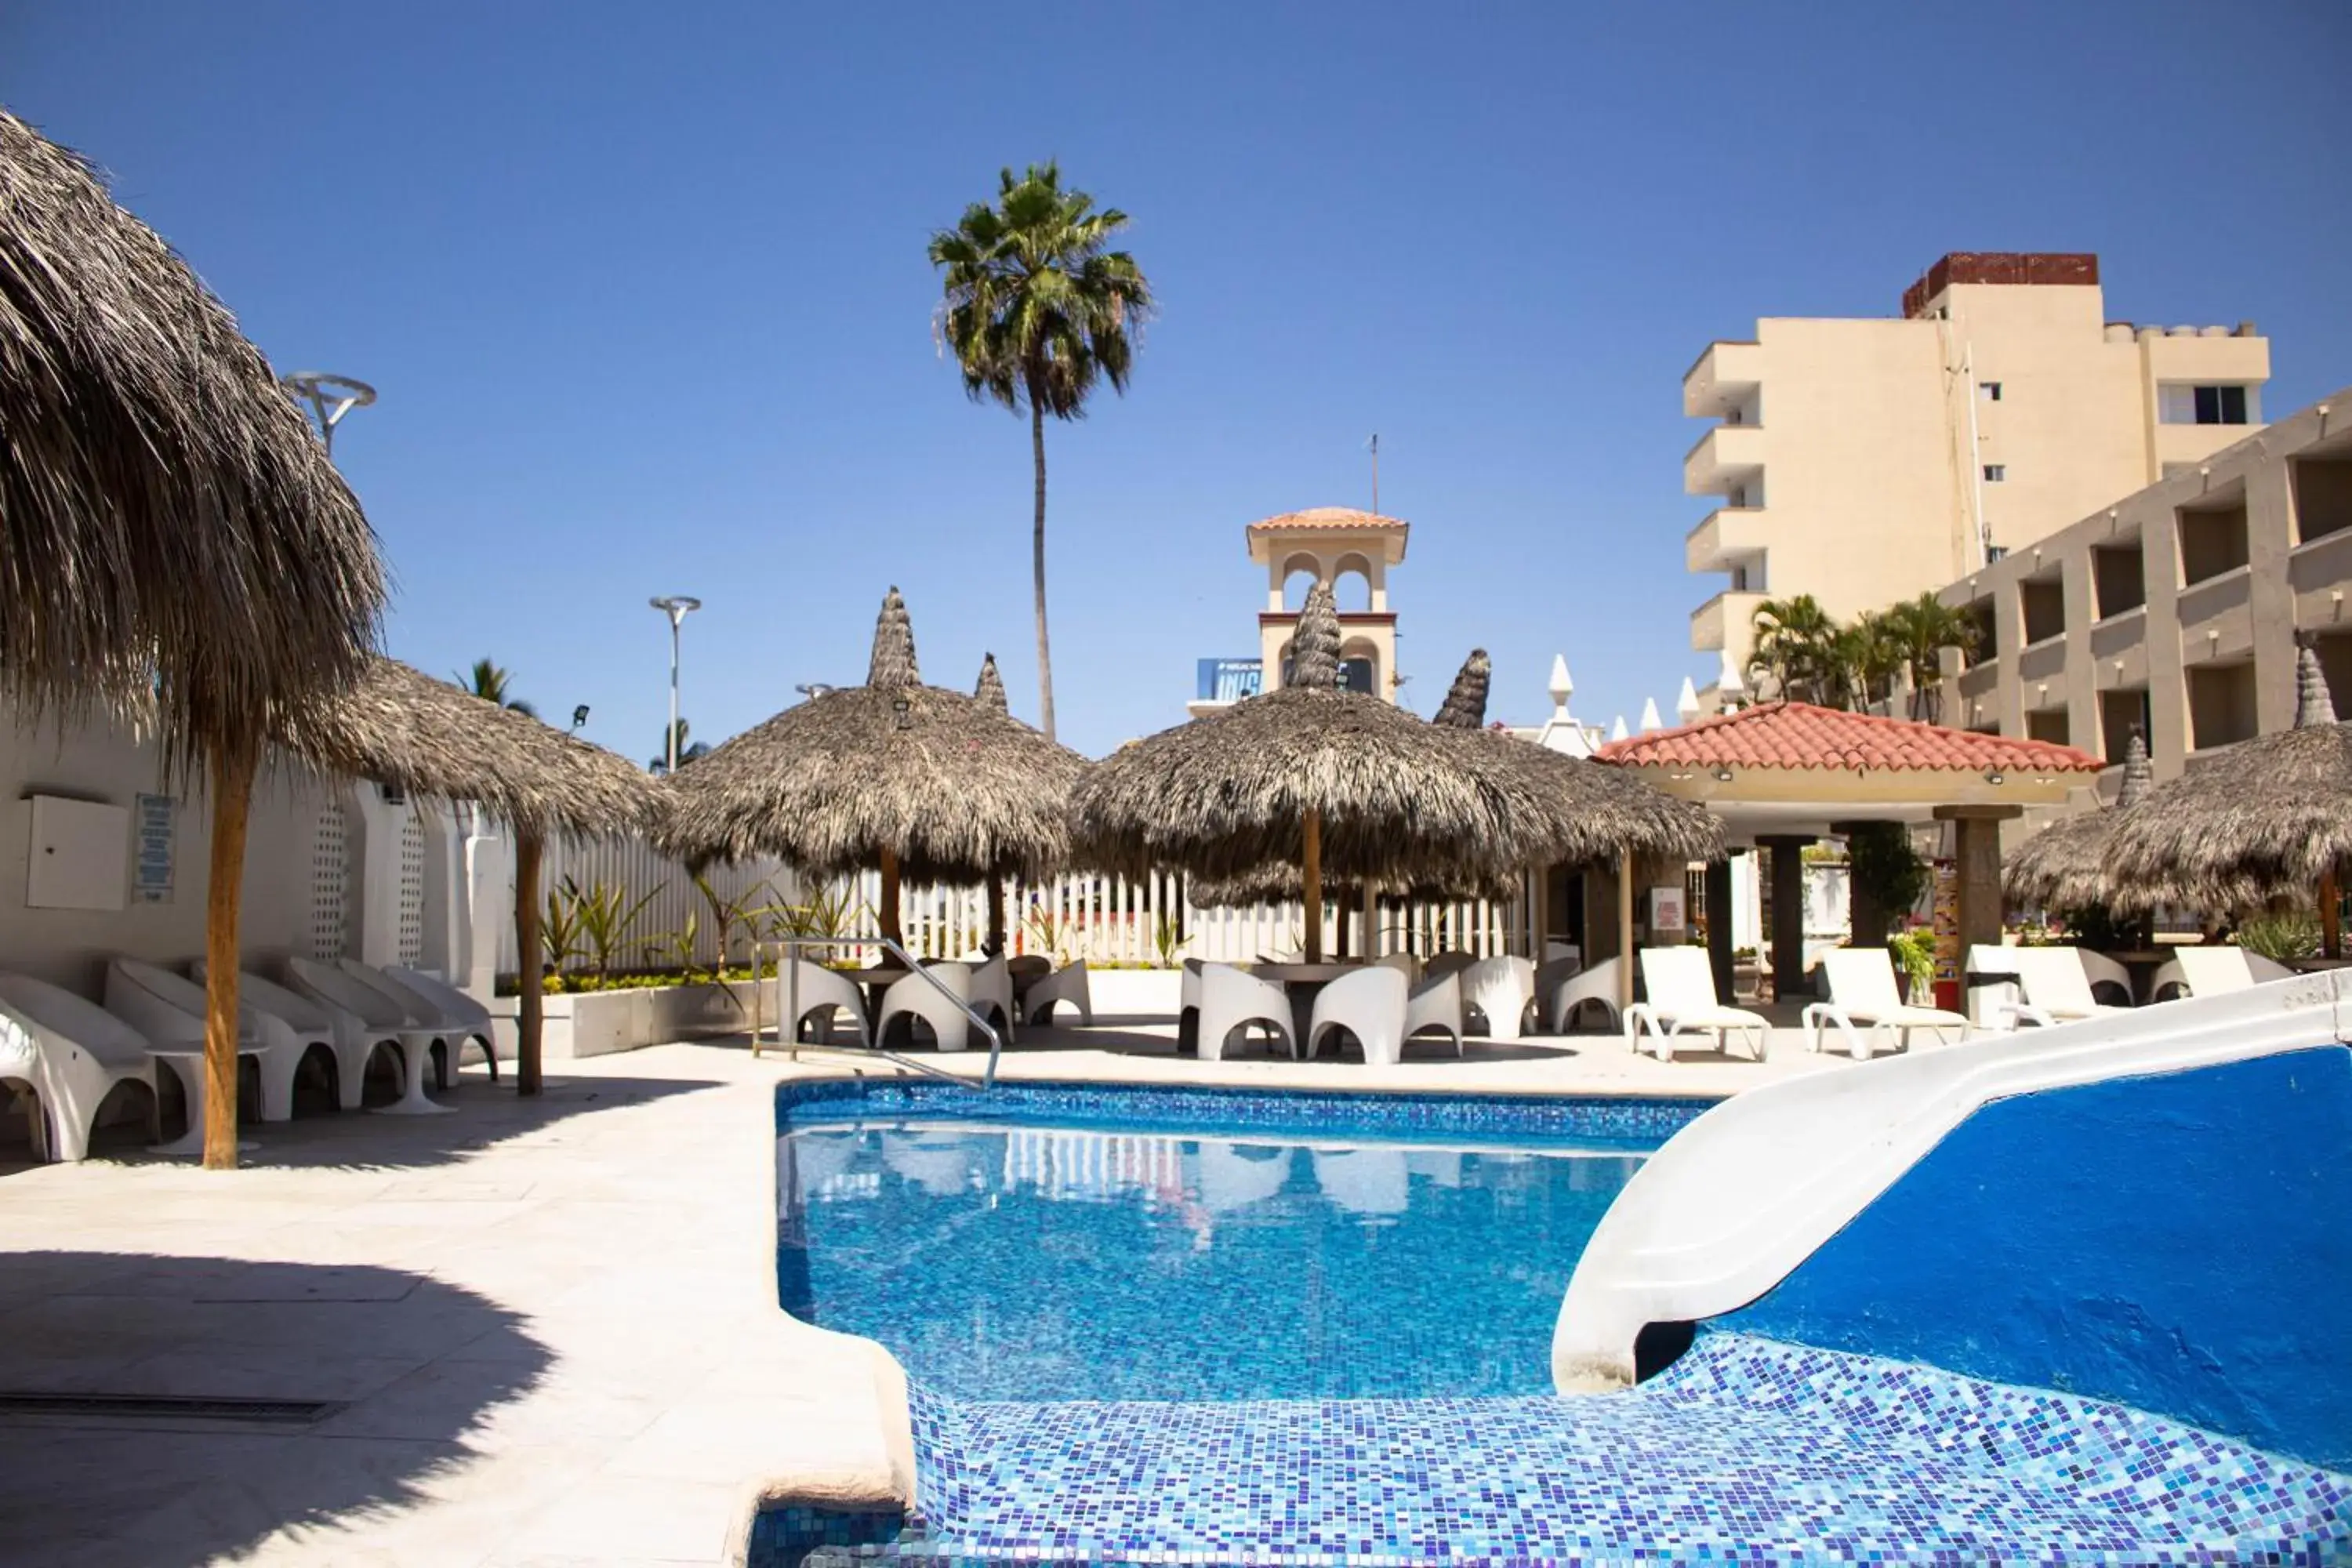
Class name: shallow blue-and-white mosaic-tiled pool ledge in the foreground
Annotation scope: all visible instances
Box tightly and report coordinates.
[764,1333,2352,1568]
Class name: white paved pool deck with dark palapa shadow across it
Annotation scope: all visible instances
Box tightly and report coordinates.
[0,1020,1849,1568]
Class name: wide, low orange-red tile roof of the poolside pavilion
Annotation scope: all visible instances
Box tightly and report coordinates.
[1597,703,2105,774]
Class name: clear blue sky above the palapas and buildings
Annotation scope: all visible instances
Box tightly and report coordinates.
[0,0,2352,760]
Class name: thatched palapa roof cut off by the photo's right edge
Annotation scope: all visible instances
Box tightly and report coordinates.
[2110,647,2352,909]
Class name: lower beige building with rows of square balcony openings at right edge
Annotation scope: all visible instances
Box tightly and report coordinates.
[1938,388,2352,797]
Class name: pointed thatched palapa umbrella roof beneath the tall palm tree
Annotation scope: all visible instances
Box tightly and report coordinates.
[661,588,1087,884]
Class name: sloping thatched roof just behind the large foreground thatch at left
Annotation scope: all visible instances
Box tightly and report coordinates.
[273,659,661,837]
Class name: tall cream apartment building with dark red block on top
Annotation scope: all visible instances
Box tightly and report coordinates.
[1682,252,2270,670]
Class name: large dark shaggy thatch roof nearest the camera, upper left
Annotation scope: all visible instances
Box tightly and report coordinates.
[0,111,383,755]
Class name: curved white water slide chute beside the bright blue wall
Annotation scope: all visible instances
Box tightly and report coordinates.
[1552,971,2352,1394]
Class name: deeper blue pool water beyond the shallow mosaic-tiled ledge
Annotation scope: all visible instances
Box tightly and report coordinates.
[776,1086,1705,1401]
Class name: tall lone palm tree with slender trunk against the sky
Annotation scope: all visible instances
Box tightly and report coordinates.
[931,162,1155,741]
